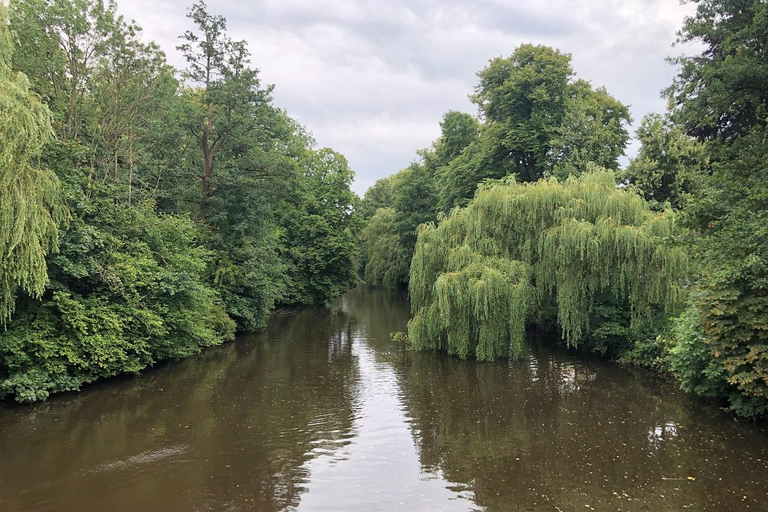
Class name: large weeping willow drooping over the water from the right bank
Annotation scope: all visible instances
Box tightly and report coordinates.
[408,169,687,361]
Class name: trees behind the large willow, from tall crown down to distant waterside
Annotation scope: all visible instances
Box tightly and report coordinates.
[360,45,630,287]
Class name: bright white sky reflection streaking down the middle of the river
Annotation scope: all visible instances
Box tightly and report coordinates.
[290,322,474,512]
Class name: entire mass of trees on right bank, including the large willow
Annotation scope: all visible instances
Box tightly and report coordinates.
[367,0,768,417]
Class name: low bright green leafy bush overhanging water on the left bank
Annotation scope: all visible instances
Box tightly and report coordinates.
[0,204,235,401]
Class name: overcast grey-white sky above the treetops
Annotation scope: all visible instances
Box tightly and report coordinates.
[118,0,693,195]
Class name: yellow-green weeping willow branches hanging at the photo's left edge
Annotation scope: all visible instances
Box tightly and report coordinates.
[0,8,66,323]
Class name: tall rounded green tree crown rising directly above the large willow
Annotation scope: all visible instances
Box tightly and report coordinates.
[436,44,631,211]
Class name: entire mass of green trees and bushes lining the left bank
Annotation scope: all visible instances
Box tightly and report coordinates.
[0,0,359,401]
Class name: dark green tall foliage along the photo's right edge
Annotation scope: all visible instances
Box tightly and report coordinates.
[668,0,768,416]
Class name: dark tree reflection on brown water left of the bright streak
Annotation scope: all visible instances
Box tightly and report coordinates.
[0,308,357,511]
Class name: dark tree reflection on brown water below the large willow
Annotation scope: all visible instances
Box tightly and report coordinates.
[399,336,763,511]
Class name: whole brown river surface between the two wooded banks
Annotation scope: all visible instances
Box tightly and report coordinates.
[0,289,768,512]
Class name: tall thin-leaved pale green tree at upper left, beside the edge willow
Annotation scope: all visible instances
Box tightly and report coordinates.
[10,0,178,202]
